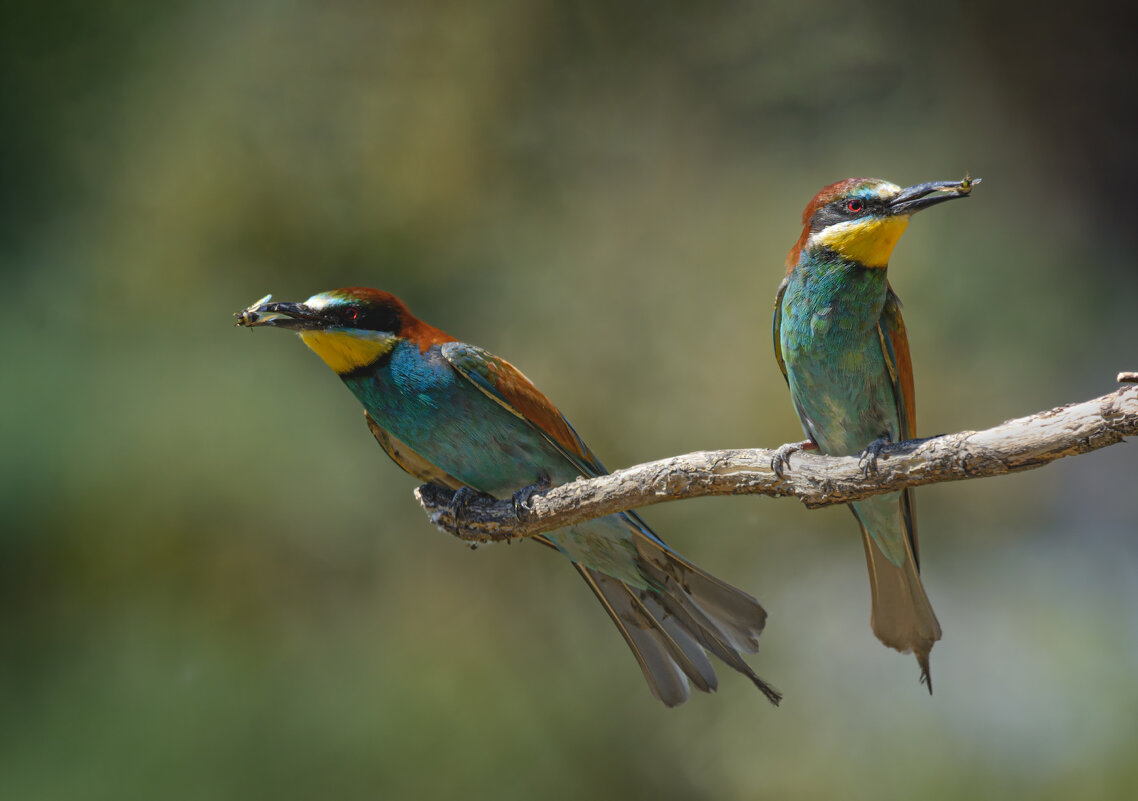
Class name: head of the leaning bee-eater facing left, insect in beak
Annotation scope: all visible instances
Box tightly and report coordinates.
[234,287,452,377]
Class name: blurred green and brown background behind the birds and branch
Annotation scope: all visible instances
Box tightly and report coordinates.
[0,0,1138,800]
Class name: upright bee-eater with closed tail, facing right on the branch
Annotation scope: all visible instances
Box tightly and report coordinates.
[774,177,980,693]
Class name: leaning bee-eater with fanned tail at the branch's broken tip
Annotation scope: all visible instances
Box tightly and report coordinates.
[238,287,781,707]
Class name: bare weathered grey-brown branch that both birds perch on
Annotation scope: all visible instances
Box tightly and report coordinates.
[415,373,1138,543]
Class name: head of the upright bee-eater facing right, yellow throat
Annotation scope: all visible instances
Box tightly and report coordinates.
[786,176,980,270]
